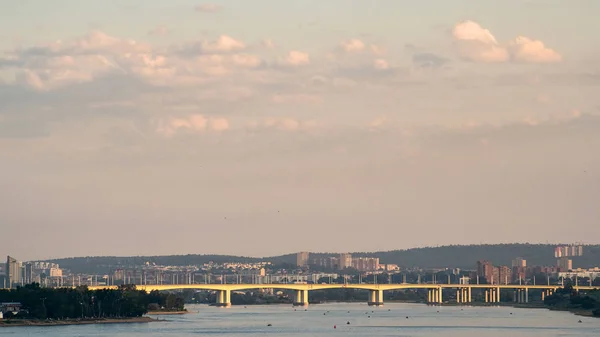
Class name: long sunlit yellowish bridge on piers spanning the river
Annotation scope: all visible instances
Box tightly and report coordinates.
[88,283,600,307]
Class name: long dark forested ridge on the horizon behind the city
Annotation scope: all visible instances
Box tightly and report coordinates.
[47,244,600,273]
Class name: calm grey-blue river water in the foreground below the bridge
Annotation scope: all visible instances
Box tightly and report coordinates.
[0,303,600,337]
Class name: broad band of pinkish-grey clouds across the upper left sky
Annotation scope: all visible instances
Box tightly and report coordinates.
[0,31,268,91]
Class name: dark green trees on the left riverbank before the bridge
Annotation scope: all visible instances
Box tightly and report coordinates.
[0,283,184,320]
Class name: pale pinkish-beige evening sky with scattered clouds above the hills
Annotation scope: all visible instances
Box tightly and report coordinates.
[0,0,600,260]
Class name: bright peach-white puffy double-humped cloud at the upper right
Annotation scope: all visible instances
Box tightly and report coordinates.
[452,20,562,63]
